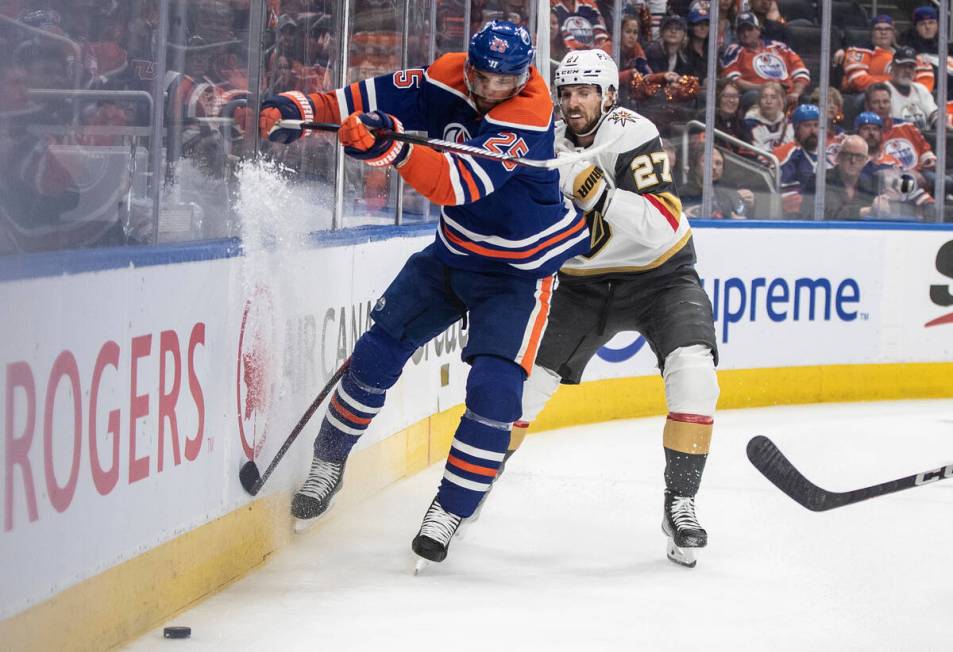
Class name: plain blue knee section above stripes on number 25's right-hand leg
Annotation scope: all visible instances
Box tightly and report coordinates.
[466,355,523,423]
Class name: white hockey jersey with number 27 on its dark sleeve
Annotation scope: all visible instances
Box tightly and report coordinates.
[556,108,695,277]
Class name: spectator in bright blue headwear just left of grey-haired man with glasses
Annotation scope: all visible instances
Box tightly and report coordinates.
[774,104,826,217]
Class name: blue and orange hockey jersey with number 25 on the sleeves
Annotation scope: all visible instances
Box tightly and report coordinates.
[332,53,589,278]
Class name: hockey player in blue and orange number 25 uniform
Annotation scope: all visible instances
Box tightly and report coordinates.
[259,21,589,561]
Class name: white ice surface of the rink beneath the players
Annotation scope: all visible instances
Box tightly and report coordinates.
[127,400,953,652]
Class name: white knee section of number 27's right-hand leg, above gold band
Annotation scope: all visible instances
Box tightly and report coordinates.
[662,344,718,417]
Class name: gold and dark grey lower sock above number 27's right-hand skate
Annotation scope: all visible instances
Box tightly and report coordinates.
[662,413,714,496]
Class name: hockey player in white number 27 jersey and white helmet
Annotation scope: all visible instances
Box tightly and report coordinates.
[490,50,718,567]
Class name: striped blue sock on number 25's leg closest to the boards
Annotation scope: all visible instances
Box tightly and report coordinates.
[314,325,416,463]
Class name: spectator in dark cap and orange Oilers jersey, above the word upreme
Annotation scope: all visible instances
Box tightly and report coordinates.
[721,12,811,105]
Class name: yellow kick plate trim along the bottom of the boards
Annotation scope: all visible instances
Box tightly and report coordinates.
[0,362,953,650]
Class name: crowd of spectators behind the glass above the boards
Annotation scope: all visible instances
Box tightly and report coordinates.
[0,0,953,254]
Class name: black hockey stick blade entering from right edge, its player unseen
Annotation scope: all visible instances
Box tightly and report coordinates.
[748,435,953,512]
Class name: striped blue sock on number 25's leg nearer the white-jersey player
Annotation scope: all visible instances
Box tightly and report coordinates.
[437,356,523,518]
